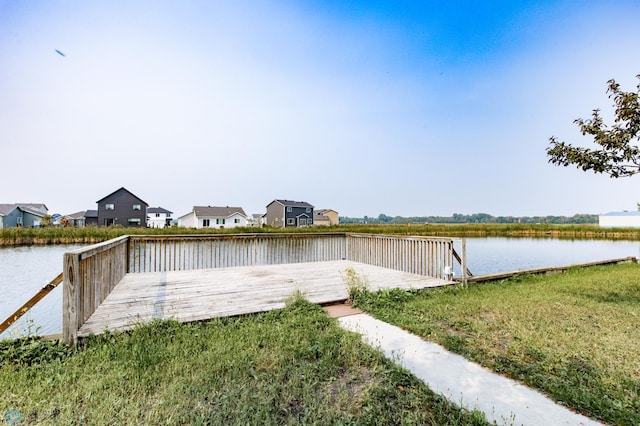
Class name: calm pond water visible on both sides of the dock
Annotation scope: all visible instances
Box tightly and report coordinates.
[0,238,640,338]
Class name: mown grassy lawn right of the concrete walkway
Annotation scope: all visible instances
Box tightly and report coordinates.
[356,264,640,425]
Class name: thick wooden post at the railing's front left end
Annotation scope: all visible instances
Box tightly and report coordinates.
[62,253,81,346]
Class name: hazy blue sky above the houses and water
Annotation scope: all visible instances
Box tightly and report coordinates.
[0,0,640,217]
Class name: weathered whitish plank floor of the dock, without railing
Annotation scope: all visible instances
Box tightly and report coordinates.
[78,260,457,336]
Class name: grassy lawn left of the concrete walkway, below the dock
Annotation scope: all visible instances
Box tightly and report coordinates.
[0,300,486,425]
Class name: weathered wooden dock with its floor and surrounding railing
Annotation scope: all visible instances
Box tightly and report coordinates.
[62,233,468,345]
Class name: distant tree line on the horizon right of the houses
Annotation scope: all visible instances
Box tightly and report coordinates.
[340,213,598,225]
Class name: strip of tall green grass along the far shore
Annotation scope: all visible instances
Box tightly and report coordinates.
[0,224,640,246]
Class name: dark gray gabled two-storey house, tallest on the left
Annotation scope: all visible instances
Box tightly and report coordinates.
[97,187,149,227]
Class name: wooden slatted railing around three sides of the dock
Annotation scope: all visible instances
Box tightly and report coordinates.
[62,233,468,344]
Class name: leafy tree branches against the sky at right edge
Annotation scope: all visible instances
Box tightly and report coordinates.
[547,74,640,178]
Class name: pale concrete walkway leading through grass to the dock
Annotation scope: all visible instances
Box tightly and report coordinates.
[326,306,601,426]
